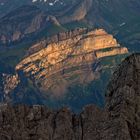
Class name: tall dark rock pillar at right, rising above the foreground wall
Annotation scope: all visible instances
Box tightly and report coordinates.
[106,54,140,140]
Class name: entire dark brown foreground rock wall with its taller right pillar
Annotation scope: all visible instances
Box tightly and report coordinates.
[0,54,140,140]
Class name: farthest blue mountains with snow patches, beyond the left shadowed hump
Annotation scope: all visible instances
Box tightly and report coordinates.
[0,0,140,51]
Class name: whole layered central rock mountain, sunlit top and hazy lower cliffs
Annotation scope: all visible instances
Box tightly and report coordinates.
[16,29,128,97]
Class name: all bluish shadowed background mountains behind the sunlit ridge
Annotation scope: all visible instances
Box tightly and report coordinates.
[0,0,140,51]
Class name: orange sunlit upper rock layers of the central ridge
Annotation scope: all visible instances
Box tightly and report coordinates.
[16,29,128,90]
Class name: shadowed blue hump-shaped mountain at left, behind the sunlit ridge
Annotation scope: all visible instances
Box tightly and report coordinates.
[0,5,60,46]
